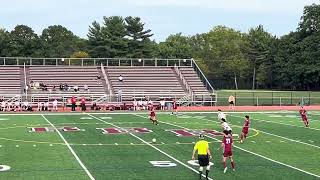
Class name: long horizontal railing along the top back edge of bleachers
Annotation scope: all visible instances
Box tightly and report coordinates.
[0,57,192,67]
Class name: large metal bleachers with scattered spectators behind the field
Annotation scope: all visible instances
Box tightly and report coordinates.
[0,57,216,105]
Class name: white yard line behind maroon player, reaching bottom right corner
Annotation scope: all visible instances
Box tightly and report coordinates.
[132,115,320,178]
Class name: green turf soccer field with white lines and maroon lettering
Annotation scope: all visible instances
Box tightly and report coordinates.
[0,111,320,180]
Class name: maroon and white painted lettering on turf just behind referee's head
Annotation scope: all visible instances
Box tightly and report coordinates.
[166,129,223,137]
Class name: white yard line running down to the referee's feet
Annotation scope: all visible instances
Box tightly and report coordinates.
[84,113,213,180]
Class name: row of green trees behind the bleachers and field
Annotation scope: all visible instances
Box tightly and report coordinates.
[0,4,320,90]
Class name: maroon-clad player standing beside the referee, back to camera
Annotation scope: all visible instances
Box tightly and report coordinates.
[221,130,235,173]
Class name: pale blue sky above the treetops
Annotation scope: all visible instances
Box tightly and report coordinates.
[0,0,319,42]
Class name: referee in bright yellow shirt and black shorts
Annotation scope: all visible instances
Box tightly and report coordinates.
[192,134,212,179]
